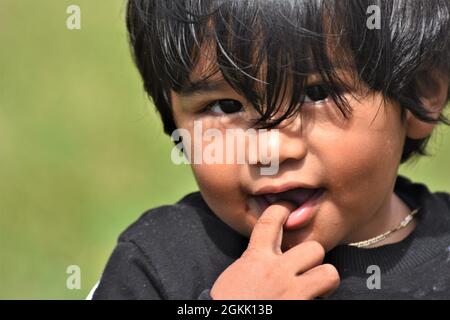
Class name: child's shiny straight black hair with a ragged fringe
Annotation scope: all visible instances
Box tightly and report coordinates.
[126,0,450,163]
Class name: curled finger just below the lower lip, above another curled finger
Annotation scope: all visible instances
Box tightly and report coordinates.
[282,241,325,273]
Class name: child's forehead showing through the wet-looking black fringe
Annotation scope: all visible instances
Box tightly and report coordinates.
[181,20,356,86]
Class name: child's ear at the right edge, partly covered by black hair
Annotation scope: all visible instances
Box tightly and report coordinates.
[406,70,449,139]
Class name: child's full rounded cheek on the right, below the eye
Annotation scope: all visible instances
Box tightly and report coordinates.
[315,105,404,210]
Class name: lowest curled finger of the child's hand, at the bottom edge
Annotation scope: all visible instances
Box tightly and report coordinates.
[298,264,340,299]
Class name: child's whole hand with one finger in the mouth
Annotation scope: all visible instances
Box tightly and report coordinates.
[210,201,340,300]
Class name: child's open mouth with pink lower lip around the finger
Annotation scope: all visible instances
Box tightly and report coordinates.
[254,188,325,230]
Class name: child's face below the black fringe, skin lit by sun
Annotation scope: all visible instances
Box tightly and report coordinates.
[171,53,412,250]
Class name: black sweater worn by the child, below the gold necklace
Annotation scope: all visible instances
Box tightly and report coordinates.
[93,176,450,299]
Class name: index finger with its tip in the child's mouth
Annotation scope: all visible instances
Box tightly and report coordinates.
[248,201,295,253]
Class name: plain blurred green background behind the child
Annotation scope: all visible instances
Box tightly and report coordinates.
[0,0,450,299]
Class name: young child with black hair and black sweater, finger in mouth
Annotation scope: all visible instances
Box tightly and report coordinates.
[93,0,450,299]
